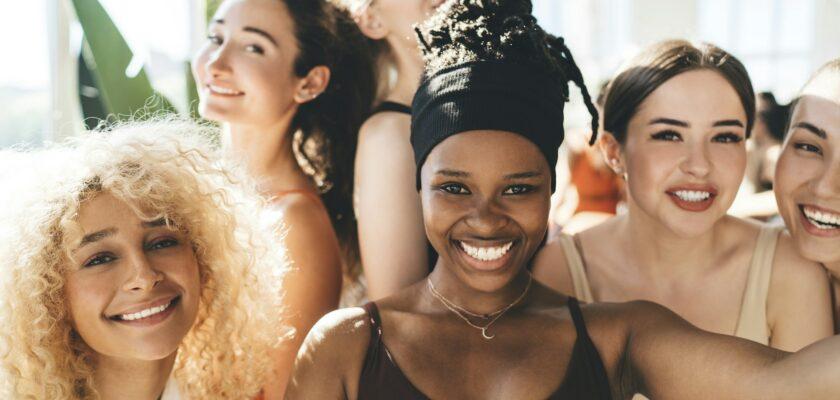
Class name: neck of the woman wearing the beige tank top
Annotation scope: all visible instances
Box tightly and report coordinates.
[615,200,717,281]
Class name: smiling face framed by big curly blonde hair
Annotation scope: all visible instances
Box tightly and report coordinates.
[65,193,200,360]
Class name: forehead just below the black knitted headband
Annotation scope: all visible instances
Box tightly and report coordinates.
[426,130,548,172]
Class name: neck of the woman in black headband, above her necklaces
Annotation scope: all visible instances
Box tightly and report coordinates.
[427,261,531,314]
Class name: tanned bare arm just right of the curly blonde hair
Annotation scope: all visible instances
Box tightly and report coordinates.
[264,195,342,399]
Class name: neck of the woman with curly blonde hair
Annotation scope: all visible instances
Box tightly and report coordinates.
[94,353,176,400]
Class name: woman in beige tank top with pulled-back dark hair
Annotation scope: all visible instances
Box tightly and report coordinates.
[533,41,832,351]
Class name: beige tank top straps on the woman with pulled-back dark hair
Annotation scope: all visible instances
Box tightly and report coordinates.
[558,226,782,346]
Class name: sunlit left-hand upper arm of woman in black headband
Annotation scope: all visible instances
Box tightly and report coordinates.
[285,308,370,400]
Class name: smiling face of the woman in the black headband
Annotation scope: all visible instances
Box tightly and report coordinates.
[421,131,551,292]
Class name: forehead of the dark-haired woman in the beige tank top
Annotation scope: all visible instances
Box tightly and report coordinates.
[636,69,746,123]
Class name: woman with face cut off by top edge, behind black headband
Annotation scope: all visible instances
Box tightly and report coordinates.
[331,0,443,299]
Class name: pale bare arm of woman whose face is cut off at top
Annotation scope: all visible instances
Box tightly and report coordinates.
[354,113,429,300]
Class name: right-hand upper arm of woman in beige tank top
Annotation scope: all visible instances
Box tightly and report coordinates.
[767,234,833,351]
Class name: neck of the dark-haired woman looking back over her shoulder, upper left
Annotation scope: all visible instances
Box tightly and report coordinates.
[223,119,314,194]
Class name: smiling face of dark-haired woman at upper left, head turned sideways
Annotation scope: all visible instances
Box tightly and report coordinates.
[192,0,301,125]
